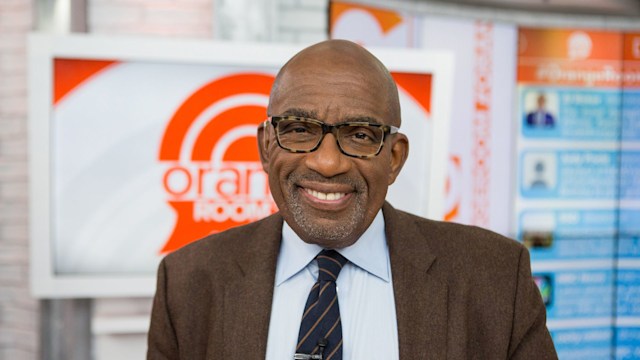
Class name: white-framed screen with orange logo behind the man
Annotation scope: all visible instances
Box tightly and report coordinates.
[29,35,452,297]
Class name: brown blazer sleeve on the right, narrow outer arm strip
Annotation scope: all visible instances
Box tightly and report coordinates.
[509,248,558,360]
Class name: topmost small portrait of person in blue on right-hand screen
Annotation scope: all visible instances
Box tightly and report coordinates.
[524,91,558,129]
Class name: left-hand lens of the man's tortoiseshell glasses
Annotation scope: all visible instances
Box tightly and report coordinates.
[276,119,322,151]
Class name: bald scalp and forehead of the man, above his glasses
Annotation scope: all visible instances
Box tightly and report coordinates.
[268,40,401,126]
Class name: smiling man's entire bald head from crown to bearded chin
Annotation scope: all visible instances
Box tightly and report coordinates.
[258,40,409,249]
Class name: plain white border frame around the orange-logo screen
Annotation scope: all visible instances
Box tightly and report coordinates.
[28,34,453,298]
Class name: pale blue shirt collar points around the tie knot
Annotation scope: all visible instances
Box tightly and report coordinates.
[276,210,390,286]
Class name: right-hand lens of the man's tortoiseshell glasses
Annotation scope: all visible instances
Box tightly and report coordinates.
[338,125,384,156]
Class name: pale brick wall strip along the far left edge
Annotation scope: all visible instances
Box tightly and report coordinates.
[0,0,38,360]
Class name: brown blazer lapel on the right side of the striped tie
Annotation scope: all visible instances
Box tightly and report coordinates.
[382,203,447,359]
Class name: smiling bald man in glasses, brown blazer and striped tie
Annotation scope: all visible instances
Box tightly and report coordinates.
[148,40,556,360]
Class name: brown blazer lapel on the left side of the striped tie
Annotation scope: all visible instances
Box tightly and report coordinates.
[223,214,282,360]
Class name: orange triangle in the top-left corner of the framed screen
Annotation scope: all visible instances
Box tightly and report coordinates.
[53,59,118,105]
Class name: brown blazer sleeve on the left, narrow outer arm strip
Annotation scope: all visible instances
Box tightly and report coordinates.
[147,259,180,360]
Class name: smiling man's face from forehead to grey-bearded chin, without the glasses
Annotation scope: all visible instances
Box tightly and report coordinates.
[259,47,408,248]
